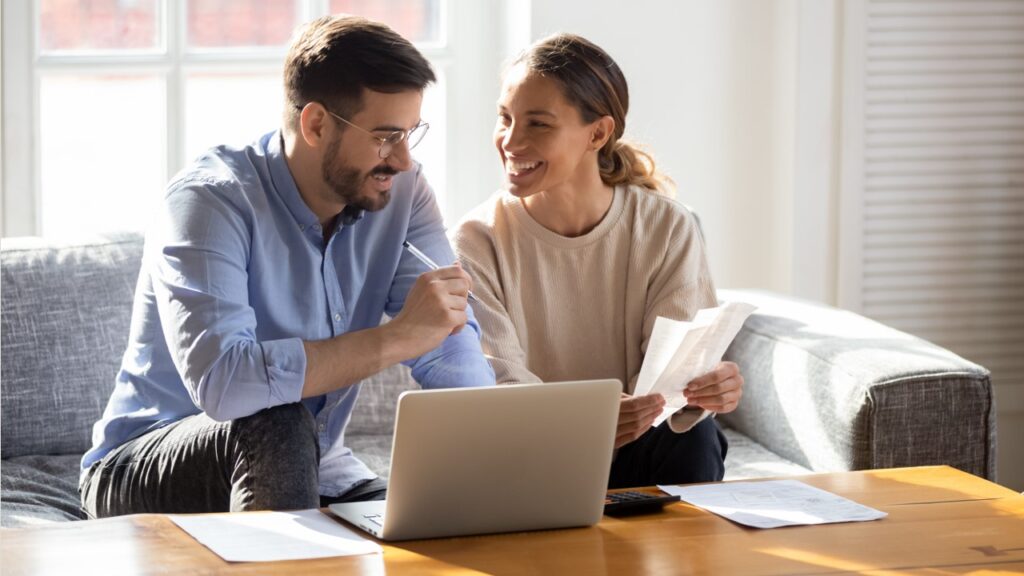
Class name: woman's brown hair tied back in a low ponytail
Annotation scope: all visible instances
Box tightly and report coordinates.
[512,34,672,194]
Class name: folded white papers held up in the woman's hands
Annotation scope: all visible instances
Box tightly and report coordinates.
[633,302,756,427]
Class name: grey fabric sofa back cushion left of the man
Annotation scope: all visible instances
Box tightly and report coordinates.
[0,235,142,459]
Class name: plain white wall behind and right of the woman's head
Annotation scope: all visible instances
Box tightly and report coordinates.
[520,0,797,292]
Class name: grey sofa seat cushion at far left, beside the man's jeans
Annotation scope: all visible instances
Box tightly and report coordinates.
[0,454,85,528]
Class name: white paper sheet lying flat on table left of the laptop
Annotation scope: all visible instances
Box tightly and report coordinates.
[170,509,381,562]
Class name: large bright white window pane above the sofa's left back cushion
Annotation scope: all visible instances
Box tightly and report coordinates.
[39,75,167,236]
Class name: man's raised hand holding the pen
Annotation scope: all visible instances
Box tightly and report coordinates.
[385,263,473,358]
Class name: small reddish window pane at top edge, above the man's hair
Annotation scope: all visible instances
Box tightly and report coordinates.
[331,0,443,43]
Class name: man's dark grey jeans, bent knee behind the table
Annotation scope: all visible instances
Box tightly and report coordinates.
[81,404,386,518]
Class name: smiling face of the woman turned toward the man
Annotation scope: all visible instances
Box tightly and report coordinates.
[495,65,598,198]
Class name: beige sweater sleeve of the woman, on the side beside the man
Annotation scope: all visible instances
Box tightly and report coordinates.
[453,214,543,384]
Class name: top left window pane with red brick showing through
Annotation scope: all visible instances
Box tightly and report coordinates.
[39,0,163,52]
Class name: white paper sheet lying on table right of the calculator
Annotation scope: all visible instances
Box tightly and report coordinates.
[658,480,888,528]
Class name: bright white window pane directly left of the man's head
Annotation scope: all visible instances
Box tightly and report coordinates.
[184,71,284,162]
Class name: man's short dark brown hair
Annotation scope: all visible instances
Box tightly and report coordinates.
[285,14,436,129]
